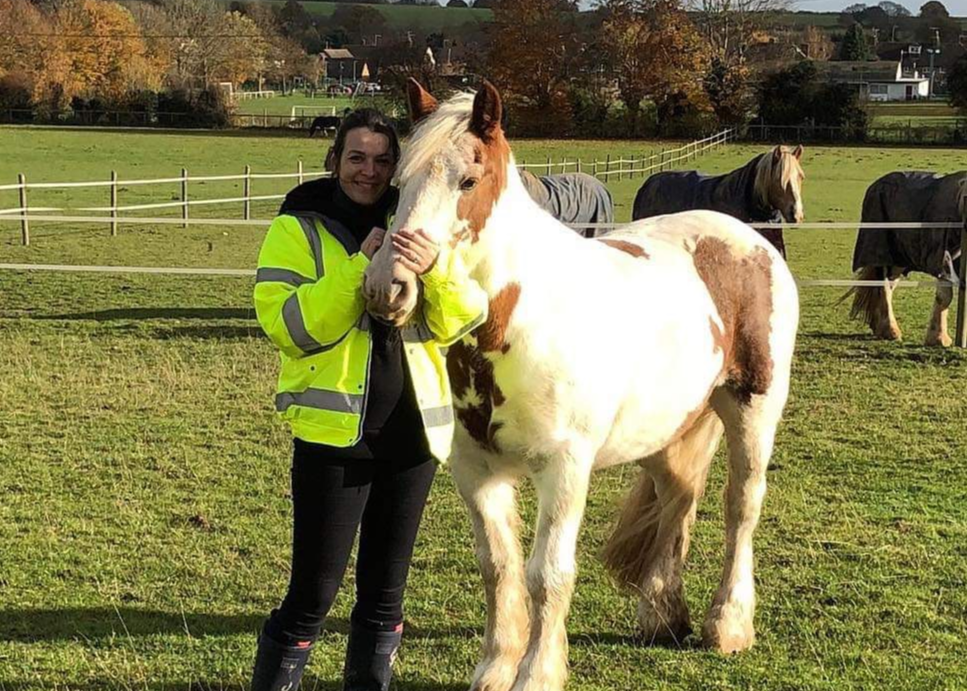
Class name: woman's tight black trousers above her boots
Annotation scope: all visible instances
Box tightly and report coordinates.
[266,439,436,645]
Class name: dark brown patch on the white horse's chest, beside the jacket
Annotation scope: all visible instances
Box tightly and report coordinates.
[447,341,506,453]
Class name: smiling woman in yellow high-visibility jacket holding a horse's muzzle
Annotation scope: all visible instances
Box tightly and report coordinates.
[252,109,486,691]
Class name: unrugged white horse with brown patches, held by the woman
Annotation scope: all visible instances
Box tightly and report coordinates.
[363,81,799,691]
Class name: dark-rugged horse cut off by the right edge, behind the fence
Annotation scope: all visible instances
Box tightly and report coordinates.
[847,171,967,346]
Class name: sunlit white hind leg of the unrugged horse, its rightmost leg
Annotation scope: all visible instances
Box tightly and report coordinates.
[702,384,788,653]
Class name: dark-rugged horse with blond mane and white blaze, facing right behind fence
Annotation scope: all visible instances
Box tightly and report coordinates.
[632,146,806,257]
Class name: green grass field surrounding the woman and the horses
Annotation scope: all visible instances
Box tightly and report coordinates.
[0,128,967,691]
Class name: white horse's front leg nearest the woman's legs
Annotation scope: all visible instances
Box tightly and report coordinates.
[452,455,527,691]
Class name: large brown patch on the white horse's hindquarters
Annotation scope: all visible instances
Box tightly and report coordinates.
[693,238,773,403]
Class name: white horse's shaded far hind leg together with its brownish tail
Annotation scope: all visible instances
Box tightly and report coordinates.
[603,410,722,645]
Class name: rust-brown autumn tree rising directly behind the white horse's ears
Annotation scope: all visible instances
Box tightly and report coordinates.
[486,0,579,135]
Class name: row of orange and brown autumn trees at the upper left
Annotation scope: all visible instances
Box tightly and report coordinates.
[0,0,318,122]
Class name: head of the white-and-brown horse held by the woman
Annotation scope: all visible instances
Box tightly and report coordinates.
[363,79,510,325]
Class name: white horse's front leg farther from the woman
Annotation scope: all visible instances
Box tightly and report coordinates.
[514,457,591,691]
